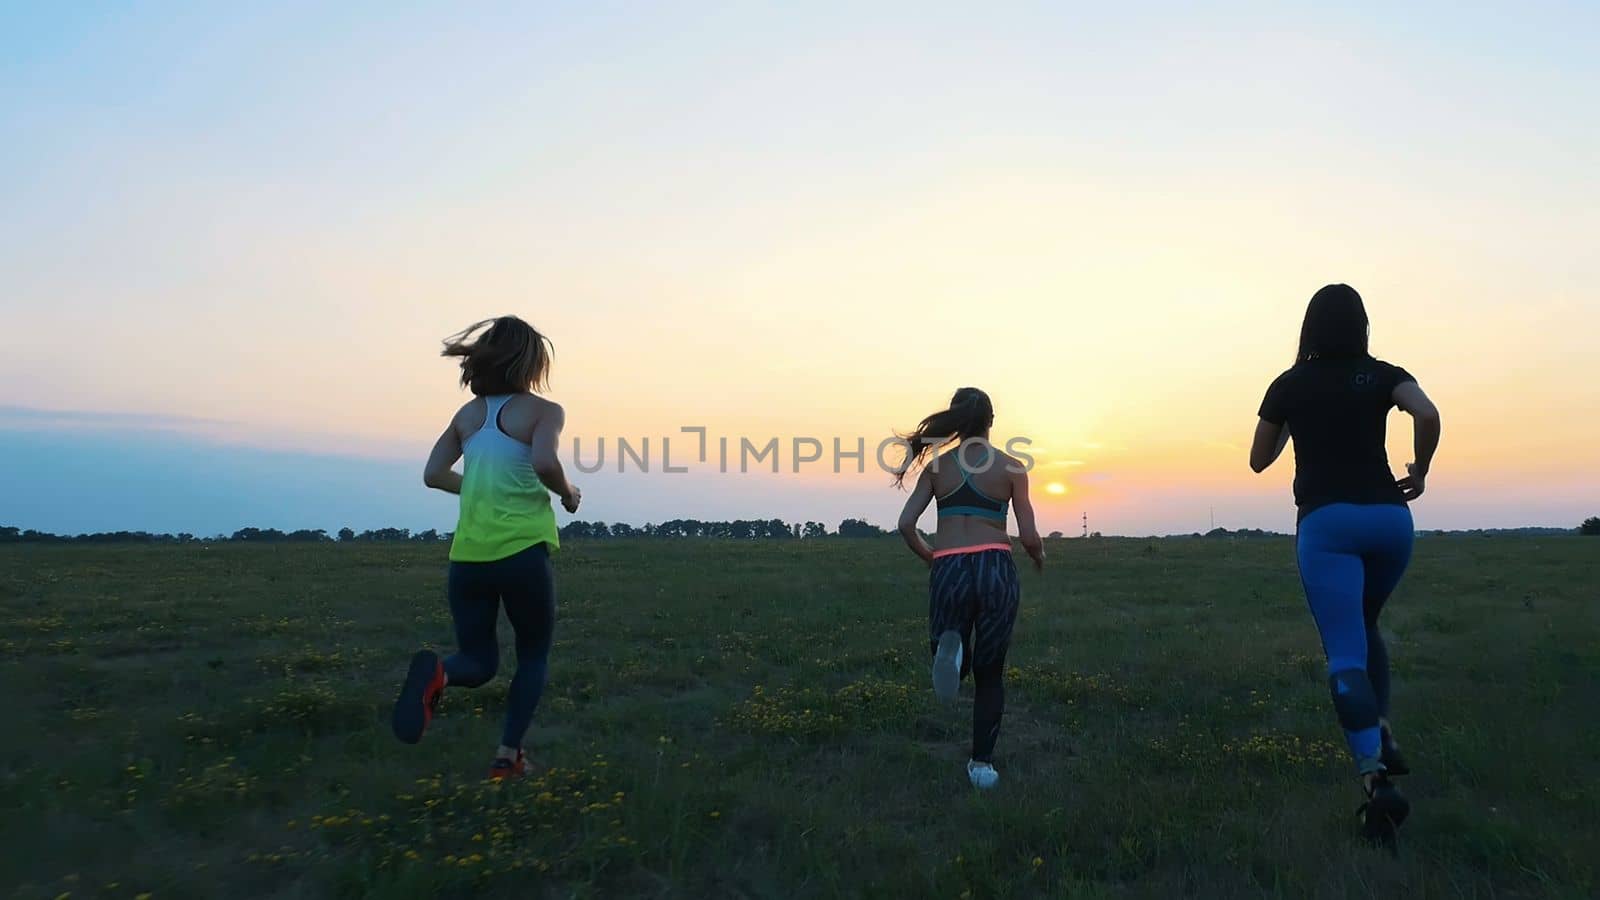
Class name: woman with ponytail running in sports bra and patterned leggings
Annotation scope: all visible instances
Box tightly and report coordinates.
[894,388,1045,790]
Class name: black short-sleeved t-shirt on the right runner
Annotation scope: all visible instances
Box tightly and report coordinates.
[1261,357,1416,519]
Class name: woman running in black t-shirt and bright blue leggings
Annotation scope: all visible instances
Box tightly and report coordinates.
[1250,285,1440,841]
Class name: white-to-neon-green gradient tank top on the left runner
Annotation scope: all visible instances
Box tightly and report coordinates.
[450,396,560,562]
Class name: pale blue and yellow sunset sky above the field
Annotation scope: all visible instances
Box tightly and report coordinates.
[0,3,1600,535]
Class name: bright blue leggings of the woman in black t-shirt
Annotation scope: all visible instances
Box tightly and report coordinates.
[1296,503,1414,773]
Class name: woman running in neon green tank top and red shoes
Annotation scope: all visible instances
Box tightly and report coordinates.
[394,315,582,778]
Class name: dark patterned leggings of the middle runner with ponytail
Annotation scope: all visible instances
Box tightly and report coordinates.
[928,549,1022,762]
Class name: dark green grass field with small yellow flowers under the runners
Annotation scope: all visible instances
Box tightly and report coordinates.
[0,536,1600,898]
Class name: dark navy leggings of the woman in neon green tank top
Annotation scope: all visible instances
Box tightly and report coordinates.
[445,544,555,746]
